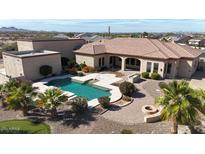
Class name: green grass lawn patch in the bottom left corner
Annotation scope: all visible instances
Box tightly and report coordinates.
[0,120,50,134]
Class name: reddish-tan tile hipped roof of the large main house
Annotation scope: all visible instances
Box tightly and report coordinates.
[75,38,202,59]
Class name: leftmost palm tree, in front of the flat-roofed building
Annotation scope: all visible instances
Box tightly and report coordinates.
[6,82,37,115]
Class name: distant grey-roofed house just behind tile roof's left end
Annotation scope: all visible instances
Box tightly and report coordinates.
[75,33,103,43]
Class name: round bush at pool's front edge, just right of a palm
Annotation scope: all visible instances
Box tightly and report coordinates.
[71,96,88,114]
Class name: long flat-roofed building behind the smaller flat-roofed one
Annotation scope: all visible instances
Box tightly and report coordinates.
[17,39,86,59]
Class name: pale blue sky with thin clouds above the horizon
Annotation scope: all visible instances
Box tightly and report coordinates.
[0,19,205,32]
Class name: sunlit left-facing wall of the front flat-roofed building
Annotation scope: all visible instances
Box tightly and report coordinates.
[3,55,24,78]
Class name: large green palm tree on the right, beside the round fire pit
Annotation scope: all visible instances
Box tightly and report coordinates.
[156,80,205,133]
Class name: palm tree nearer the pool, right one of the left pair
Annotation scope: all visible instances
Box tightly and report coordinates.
[37,88,68,117]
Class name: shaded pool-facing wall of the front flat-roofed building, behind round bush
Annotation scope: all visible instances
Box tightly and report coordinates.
[22,54,62,80]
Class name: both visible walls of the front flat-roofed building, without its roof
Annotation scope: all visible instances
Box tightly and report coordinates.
[3,54,62,80]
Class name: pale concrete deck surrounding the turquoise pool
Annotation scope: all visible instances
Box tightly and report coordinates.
[33,73,122,108]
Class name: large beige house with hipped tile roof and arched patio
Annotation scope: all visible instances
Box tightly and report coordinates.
[75,38,201,78]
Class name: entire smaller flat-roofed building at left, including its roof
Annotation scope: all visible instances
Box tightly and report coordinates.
[3,50,62,81]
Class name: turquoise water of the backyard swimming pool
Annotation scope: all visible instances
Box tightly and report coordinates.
[47,79,111,101]
